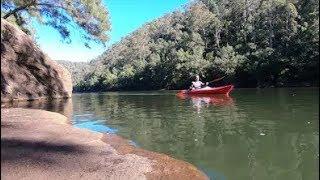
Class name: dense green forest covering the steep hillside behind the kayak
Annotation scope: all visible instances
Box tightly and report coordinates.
[64,0,319,91]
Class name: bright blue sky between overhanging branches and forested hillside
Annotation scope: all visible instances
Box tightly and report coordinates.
[36,0,189,62]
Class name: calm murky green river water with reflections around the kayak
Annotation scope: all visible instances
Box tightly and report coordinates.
[6,88,319,180]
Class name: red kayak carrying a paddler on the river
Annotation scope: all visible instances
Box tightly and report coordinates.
[178,85,233,95]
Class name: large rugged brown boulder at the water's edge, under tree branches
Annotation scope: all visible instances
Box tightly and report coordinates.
[1,19,72,102]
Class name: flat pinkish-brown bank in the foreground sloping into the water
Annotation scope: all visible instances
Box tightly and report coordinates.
[1,108,207,179]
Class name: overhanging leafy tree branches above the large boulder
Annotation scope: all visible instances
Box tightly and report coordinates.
[1,0,110,47]
